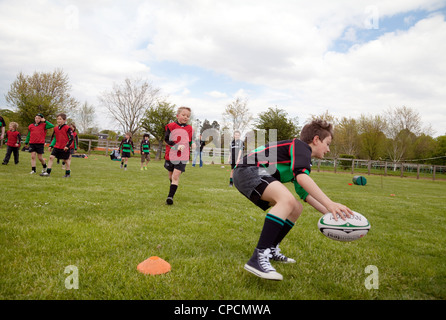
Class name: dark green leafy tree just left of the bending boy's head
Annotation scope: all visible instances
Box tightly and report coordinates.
[255,106,300,142]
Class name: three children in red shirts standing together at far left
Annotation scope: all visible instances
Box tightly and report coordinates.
[2,113,78,178]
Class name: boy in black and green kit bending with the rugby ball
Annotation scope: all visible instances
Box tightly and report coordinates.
[233,120,352,280]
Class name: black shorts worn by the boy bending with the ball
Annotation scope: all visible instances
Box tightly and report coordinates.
[233,166,278,211]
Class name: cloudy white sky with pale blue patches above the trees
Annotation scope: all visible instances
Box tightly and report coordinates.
[0,0,446,136]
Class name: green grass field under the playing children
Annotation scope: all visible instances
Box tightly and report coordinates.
[0,148,446,300]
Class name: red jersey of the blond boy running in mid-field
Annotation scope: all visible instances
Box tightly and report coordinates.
[164,122,193,161]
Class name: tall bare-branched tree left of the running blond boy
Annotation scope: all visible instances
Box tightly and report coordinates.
[99,78,160,134]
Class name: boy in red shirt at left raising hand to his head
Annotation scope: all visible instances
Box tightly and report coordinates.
[25,113,54,174]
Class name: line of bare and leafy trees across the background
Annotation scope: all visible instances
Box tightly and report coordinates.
[0,69,446,165]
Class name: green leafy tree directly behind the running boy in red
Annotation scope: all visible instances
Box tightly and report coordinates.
[140,101,176,160]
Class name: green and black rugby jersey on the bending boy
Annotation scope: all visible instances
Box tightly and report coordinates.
[237,139,311,200]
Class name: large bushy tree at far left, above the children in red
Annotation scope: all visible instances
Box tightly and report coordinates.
[5,69,78,125]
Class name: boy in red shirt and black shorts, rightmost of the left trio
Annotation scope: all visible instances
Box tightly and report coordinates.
[40,113,73,178]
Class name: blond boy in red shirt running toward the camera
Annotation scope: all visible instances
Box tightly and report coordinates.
[164,107,193,205]
